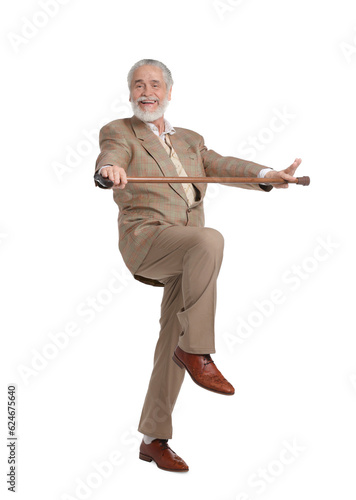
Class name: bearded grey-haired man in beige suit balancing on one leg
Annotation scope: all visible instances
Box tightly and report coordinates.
[95,59,301,472]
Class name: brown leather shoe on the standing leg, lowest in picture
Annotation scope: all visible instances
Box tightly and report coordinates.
[139,439,189,472]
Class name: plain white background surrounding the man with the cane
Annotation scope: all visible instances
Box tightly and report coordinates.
[0,0,356,500]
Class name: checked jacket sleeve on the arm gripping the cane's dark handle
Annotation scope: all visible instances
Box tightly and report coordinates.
[95,123,131,173]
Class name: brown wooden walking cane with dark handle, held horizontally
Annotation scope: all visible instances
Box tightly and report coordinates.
[94,173,310,189]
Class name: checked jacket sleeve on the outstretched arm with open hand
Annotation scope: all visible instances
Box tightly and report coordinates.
[199,136,273,191]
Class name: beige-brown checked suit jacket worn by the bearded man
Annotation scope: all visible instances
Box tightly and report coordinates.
[95,116,272,286]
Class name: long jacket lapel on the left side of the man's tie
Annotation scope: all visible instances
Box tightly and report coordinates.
[131,116,189,205]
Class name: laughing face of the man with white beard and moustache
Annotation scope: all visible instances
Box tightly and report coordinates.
[130,65,172,121]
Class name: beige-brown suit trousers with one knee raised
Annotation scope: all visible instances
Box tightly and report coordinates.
[136,226,224,439]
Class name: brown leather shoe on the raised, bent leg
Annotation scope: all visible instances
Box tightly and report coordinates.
[173,346,235,396]
